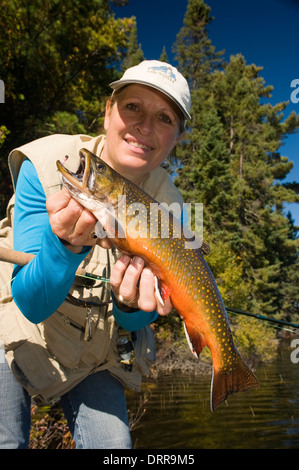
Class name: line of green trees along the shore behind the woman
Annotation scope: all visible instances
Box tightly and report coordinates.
[0,0,299,354]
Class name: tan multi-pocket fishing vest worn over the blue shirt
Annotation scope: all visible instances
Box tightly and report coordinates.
[0,135,182,404]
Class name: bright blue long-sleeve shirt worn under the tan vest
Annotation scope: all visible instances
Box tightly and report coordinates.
[12,160,158,331]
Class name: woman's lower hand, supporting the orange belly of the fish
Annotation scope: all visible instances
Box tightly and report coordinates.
[110,255,172,315]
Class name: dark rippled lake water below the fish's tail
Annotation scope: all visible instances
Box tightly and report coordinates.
[128,340,299,449]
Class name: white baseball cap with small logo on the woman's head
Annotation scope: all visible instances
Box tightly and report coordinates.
[110,60,191,119]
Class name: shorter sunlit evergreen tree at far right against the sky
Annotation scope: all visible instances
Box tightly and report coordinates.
[213,55,299,320]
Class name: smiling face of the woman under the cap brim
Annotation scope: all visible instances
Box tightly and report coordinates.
[102,84,181,184]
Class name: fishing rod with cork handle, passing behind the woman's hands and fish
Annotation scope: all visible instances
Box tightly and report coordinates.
[0,247,299,330]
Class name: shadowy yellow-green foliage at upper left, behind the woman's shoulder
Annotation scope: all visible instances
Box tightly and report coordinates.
[0,0,136,215]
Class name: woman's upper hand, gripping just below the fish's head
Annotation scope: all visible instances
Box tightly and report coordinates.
[46,188,112,253]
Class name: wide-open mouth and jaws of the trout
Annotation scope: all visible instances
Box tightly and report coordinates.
[56,151,94,194]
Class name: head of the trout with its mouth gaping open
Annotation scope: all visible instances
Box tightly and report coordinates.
[56,149,124,213]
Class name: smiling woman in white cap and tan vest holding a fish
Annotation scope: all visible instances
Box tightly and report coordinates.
[0,61,190,448]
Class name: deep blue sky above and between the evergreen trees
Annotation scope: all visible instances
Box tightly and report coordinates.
[114,0,299,225]
